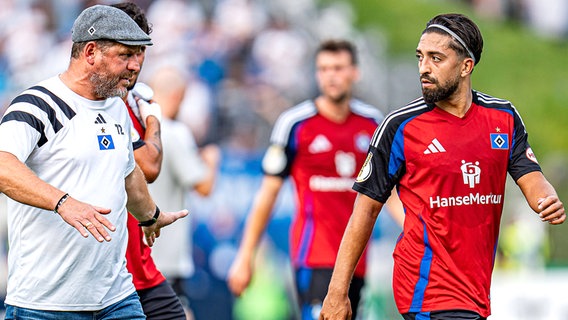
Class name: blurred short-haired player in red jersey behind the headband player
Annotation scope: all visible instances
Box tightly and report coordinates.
[228,40,403,319]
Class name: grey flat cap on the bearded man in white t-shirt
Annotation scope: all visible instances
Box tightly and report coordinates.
[71,5,152,46]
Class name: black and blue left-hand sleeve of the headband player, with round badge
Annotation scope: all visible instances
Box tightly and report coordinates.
[353,117,406,203]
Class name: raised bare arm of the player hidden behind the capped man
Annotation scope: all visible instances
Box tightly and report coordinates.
[134,116,163,183]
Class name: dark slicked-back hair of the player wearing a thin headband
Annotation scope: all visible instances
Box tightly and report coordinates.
[422,13,483,64]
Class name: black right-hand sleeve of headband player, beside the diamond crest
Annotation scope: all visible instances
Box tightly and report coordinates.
[507,106,542,181]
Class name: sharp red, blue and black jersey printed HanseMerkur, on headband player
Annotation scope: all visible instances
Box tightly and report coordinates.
[354,91,540,317]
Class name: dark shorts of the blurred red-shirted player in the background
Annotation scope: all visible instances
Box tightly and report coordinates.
[296,268,365,320]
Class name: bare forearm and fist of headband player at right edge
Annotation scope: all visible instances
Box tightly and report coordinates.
[517,171,566,224]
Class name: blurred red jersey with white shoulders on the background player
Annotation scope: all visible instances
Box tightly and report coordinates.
[263,100,382,276]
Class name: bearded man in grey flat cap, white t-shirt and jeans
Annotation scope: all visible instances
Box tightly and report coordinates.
[0,5,187,320]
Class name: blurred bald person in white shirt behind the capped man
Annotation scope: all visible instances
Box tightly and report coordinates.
[148,66,221,313]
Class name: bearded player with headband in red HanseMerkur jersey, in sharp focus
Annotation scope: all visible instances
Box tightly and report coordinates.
[320,14,566,320]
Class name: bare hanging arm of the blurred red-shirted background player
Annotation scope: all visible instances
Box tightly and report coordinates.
[227,175,284,296]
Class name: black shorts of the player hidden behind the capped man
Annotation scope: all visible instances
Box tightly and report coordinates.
[138,281,186,320]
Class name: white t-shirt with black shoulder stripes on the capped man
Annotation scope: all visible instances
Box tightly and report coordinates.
[0,77,135,311]
